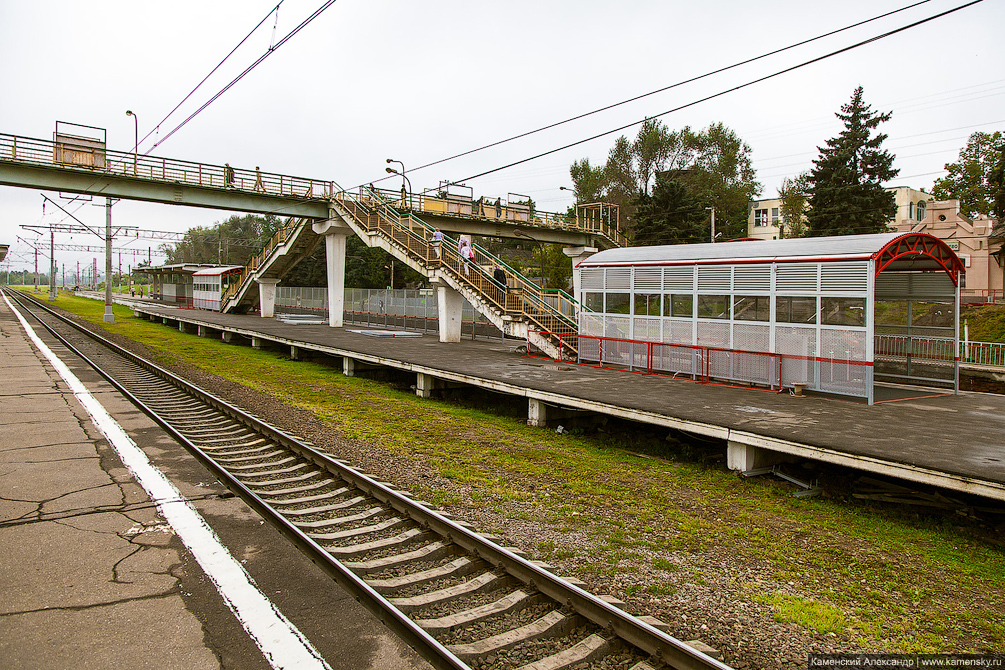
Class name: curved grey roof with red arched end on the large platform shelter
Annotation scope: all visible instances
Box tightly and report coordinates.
[577,233,965,282]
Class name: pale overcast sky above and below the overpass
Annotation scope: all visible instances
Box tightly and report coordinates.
[0,0,1005,270]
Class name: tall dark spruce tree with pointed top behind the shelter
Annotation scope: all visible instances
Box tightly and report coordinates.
[807,86,899,237]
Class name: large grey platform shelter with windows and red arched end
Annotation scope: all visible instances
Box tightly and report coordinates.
[576,233,965,404]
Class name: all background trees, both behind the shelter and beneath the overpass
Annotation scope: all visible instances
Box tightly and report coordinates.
[161,86,1005,288]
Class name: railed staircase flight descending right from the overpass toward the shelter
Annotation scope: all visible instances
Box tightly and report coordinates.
[335,187,579,354]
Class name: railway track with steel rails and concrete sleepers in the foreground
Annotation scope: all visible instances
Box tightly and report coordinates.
[8,291,729,670]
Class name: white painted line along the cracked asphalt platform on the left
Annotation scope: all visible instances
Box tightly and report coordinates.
[4,295,331,670]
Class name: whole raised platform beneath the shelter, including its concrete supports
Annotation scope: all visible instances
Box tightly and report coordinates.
[123,301,1005,500]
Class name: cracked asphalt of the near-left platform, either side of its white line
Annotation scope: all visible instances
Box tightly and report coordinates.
[0,301,428,670]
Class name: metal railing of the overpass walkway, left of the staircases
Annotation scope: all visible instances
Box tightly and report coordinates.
[0,133,339,200]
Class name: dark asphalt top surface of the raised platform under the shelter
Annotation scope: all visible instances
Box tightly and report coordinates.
[129,305,1005,492]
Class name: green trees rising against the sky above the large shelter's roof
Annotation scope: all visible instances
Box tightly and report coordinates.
[569,86,1005,246]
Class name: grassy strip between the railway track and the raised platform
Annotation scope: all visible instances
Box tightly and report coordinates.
[29,296,1005,652]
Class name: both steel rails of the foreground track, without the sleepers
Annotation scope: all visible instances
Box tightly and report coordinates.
[5,293,731,670]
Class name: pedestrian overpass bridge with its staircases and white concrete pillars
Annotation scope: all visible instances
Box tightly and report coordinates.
[0,134,625,357]
